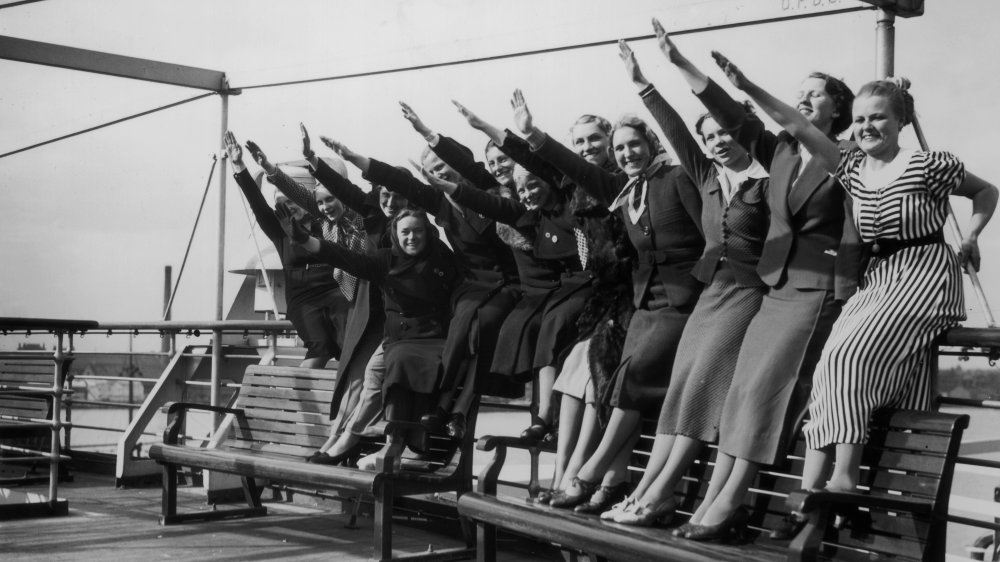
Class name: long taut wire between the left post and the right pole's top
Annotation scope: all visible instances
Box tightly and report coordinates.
[234,6,875,90]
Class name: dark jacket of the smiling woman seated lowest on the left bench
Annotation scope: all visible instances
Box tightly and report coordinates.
[318,240,462,343]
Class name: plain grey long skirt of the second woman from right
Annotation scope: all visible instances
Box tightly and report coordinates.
[719,285,841,464]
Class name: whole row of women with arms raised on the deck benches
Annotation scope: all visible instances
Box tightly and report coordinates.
[227,20,997,540]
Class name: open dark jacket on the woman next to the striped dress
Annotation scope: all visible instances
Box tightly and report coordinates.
[698,81,861,300]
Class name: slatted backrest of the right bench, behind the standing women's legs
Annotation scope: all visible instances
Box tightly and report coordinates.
[630,410,969,560]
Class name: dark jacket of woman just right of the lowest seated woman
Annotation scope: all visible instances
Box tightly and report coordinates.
[365,153,517,281]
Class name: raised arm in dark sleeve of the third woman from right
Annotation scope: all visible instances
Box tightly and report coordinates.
[618,40,717,185]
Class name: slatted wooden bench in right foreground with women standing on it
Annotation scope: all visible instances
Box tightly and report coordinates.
[458,410,969,562]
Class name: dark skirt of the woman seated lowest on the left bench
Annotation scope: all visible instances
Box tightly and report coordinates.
[382,338,444,396]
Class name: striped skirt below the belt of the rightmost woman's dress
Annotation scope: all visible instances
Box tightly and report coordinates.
[804,243,965,449]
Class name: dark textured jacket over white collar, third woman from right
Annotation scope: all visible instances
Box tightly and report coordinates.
[639,86,769,287]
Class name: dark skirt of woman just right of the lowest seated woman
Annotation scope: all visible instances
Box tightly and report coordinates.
[441,274,521,392]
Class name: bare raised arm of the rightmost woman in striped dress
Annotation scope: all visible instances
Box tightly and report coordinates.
[712,51,840,172]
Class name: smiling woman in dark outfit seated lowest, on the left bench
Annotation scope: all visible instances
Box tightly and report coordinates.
[279,203,461,466]
